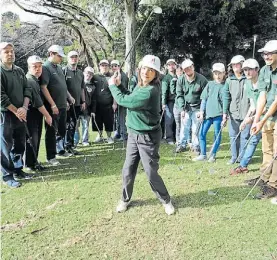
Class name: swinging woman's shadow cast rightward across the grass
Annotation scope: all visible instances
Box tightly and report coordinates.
[130,186,252,209]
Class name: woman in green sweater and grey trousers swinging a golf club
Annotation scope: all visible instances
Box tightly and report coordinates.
[109,55,175,215]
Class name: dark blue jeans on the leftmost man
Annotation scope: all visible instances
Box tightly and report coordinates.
[0,111,26,181]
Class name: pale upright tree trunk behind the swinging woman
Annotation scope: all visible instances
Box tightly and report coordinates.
[125,0,137,77]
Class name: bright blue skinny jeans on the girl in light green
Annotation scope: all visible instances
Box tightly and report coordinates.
[199,116,222,155]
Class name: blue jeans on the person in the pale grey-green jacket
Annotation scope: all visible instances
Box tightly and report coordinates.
[228,118,251,160]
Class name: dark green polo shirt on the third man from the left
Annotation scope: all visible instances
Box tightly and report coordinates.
[41,60,67,108]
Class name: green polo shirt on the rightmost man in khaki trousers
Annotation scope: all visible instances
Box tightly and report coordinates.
[258,65,277,121]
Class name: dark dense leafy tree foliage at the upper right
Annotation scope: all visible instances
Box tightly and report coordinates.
[136,0,277,74]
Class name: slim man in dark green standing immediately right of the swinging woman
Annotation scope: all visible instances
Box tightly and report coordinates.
[162,59,177,145]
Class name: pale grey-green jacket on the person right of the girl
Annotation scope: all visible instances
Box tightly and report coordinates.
[223,75,250,120]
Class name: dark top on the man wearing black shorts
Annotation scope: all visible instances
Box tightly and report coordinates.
[94,73,113,106]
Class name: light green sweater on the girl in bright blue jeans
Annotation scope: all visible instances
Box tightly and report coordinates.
[201,81,228,118]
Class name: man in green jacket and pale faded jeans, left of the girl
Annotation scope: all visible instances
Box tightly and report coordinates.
[176,59,208,154]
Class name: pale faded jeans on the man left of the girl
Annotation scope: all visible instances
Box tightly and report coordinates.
[180,110,199,149]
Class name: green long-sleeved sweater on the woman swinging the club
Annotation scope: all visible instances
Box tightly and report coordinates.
[109,85,160,134]
